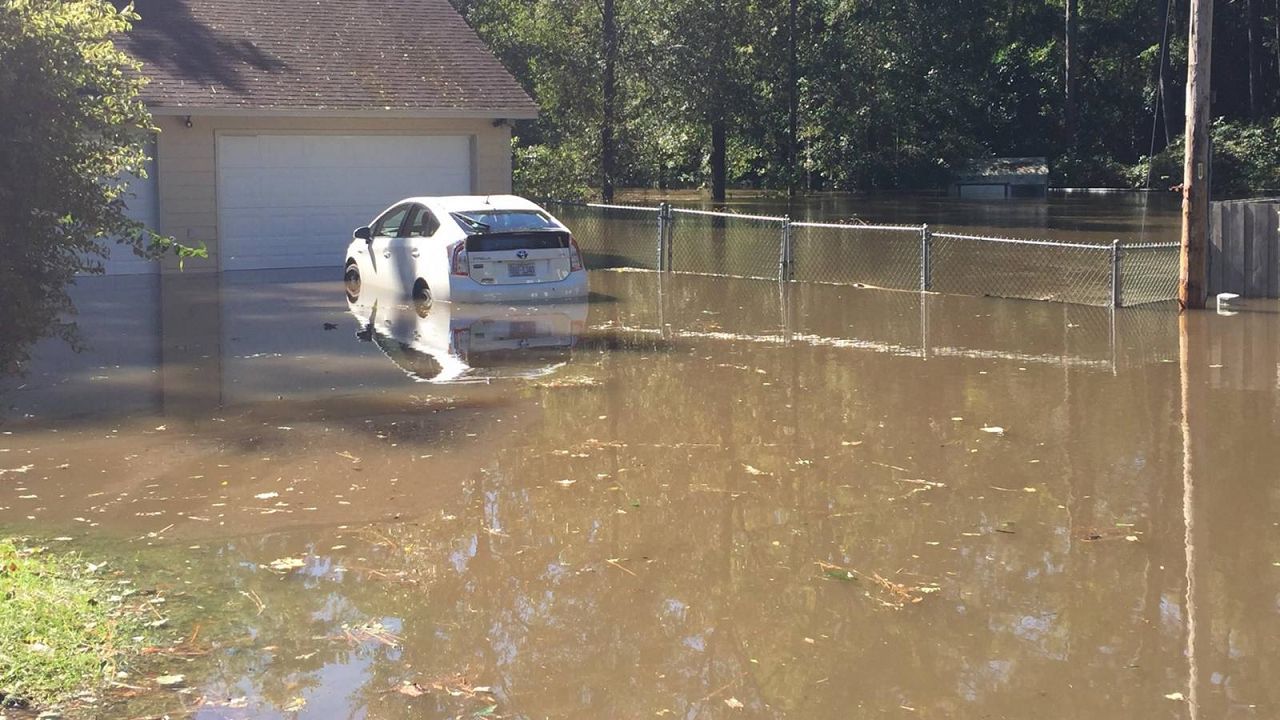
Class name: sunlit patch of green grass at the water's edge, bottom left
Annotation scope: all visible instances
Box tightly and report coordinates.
[0,541,147,707]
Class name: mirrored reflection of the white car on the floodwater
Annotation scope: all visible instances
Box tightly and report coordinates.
[347,284,586,383]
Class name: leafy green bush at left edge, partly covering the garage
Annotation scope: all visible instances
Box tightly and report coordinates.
[0,0,198,372]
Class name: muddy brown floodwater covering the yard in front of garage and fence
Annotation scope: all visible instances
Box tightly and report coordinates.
[0,273,1280,719]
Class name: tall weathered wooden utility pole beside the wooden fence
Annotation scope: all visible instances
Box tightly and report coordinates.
[1178,0,1213,310]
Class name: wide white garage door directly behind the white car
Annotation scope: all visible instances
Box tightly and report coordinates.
[218,135,471,270]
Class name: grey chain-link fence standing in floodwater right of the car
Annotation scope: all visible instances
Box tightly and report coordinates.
[544,200,1178,307]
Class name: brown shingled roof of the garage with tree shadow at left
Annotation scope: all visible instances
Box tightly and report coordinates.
[123,0,538,118]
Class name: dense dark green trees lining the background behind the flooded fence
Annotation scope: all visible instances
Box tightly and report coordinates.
[454,0,1280,196]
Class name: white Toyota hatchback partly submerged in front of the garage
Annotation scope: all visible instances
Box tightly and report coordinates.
[343,195,588,302]
